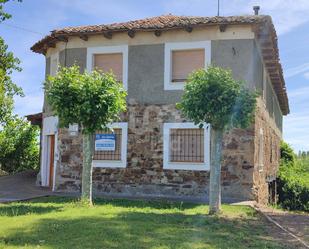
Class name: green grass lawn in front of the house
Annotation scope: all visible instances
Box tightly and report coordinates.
[0,197,284,249]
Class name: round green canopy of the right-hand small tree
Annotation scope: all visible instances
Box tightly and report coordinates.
[177,66,257,130]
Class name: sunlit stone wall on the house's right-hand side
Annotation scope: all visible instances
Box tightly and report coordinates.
[253,98,282,204]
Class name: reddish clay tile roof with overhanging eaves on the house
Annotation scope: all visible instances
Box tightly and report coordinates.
[31,15,289,115]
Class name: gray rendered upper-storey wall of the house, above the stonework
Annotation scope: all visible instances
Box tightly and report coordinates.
[46,39,282,127]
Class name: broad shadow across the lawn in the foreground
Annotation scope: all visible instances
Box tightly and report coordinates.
[0,212,283,249]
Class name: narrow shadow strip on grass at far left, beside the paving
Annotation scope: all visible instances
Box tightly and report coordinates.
[0,203,61,216]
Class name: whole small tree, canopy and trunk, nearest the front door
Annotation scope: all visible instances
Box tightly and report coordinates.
[45,65,126,204]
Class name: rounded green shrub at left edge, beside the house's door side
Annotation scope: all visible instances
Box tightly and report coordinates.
[0,116,39,173]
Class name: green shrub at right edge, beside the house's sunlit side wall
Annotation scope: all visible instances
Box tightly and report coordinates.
[277,143,309,212]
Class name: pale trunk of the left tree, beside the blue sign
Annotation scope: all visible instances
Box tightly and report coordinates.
[82,134,93,205]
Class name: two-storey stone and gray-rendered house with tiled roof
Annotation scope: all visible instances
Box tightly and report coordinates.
[31,15,289,203]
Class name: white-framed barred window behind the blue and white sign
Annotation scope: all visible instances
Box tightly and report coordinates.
[92,122,128,168]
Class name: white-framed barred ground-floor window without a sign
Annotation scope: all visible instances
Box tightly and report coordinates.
[163,122,210,171]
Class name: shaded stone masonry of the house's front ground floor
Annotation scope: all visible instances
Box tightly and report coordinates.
[56,104,255,200]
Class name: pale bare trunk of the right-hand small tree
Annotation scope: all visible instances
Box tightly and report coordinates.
[209,129,223,214]
